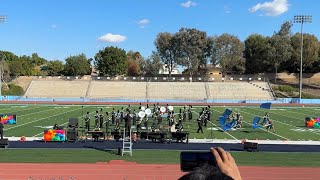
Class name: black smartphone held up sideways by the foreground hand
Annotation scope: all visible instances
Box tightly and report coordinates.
[180,151,216,172]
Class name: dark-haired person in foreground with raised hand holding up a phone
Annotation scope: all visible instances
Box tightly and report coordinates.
[179,147,242,180]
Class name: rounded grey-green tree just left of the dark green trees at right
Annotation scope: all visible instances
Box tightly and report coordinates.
[212,34,245,73]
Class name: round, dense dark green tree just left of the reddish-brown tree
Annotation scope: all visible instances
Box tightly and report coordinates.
[94,46,128,76]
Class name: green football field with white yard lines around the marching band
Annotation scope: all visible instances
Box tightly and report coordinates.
[0,105,320,141]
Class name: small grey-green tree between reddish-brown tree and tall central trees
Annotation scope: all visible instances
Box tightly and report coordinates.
[144,51,163,76]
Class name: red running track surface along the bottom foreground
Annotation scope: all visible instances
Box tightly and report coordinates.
[0,160,320,180]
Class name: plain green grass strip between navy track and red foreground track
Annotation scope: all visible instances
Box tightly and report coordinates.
[0,149,320,167]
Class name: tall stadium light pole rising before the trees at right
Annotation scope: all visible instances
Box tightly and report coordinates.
[293,15,312,103]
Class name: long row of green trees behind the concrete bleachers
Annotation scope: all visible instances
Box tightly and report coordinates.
[0,22,320,77]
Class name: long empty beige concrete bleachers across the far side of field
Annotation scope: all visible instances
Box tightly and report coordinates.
[25,80,273,101]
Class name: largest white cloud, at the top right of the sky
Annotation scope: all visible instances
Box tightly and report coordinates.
[249,0,289,16]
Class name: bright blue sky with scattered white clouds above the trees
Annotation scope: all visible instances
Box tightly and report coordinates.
[0,0,320,61]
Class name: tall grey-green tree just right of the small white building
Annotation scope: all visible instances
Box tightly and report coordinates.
[175,28,207,77]
